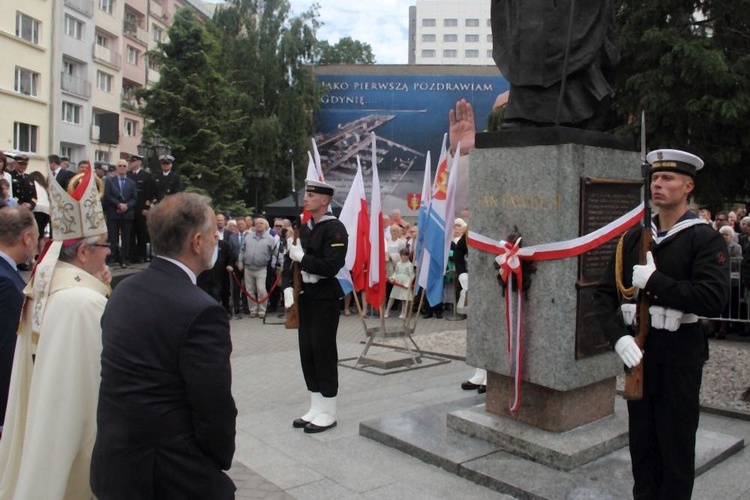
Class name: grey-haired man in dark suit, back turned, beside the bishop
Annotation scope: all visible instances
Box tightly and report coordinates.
[91,193,237,500]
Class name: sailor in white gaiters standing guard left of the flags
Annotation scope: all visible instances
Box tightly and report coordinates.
[284,180,349,433]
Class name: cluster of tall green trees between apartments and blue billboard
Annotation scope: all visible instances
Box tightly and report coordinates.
[140,0,374,213]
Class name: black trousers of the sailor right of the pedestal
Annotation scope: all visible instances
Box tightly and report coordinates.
[628,363,703,499]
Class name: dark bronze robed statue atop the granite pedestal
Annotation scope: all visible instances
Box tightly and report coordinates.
[492,0,619,130]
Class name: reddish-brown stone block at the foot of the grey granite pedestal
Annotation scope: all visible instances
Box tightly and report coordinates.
[487,372,616,432]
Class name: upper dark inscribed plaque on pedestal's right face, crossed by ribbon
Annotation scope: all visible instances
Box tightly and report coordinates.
[578,178,643,285]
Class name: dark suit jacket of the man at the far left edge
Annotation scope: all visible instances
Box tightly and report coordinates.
[0,257,26,425]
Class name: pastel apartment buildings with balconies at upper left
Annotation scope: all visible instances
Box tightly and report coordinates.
[0,0,212,169]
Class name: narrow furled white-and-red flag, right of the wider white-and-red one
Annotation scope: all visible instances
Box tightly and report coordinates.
[365,133,386,309]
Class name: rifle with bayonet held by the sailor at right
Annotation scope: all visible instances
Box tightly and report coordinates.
[622,111,651,400]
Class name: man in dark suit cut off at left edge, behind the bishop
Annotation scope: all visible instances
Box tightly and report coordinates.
[0,207,39,436]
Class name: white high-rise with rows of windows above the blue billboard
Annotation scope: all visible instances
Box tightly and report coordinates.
[408,0,495,66]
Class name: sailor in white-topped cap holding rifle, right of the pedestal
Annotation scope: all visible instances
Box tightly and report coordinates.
[594,149,729,499]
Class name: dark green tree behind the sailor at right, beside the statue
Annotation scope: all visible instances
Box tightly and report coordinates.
[616,0,750,208]
